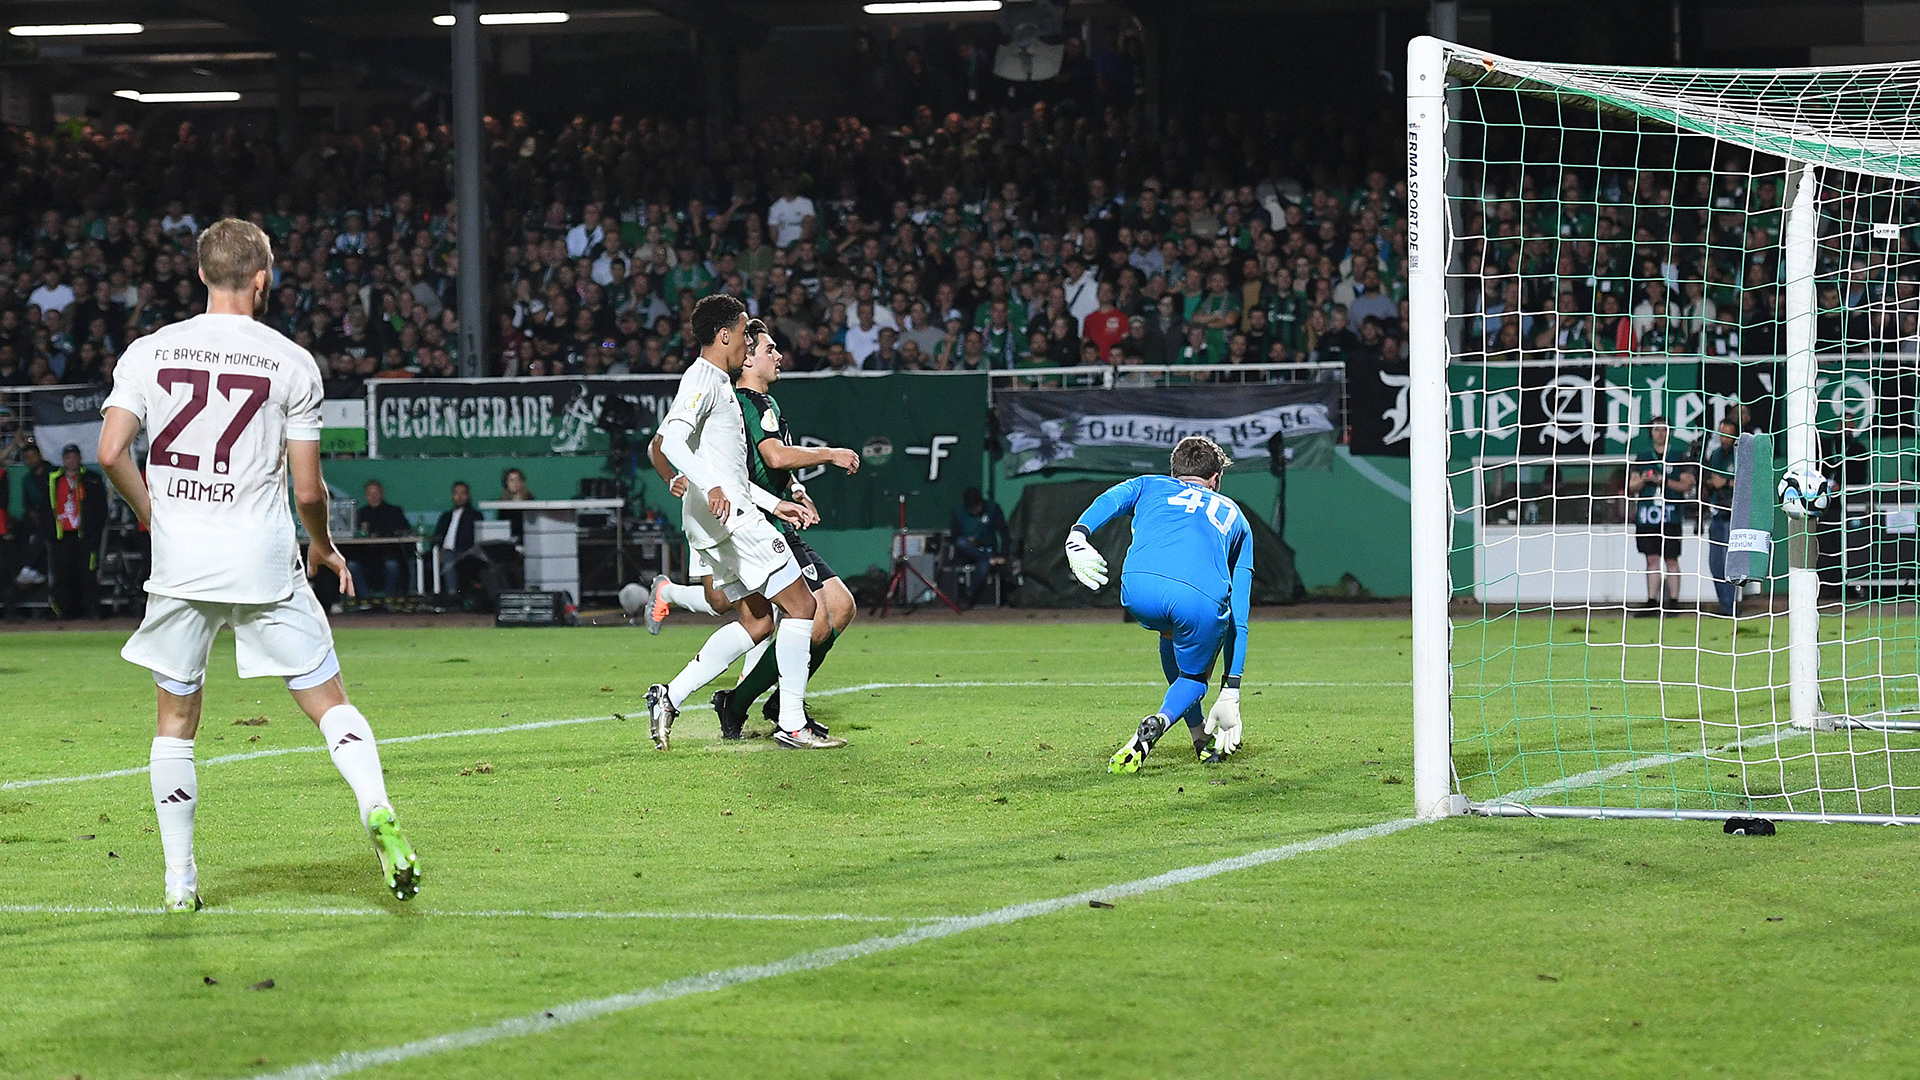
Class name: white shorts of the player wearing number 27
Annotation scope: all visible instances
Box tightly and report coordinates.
[121,582,334,686]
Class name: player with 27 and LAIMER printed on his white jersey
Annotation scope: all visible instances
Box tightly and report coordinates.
[100,217,420,911]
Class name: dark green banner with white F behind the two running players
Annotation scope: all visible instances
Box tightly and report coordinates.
[774,371,987,528]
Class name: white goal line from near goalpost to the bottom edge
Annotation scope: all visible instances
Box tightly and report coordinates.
[253,819,1421,1080]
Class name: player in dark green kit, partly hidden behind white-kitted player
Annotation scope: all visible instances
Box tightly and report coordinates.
[647,319,860,742]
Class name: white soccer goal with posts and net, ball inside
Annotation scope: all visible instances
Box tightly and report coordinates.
[1407,38,1920,821]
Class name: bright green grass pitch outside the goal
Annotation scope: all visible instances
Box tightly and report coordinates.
[0,615,1920,1080]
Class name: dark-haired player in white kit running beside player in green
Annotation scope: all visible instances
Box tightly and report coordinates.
[647,294,847,749]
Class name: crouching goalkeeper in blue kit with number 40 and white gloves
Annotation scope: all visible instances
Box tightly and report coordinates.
[1068,434,1254,773]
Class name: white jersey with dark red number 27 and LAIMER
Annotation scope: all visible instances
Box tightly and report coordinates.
[102,315,323,605]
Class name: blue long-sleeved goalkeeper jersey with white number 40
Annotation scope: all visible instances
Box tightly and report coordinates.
[1075,475,1254,676]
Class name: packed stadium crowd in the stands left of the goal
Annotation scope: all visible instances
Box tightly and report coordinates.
[0,85,1405,405]
